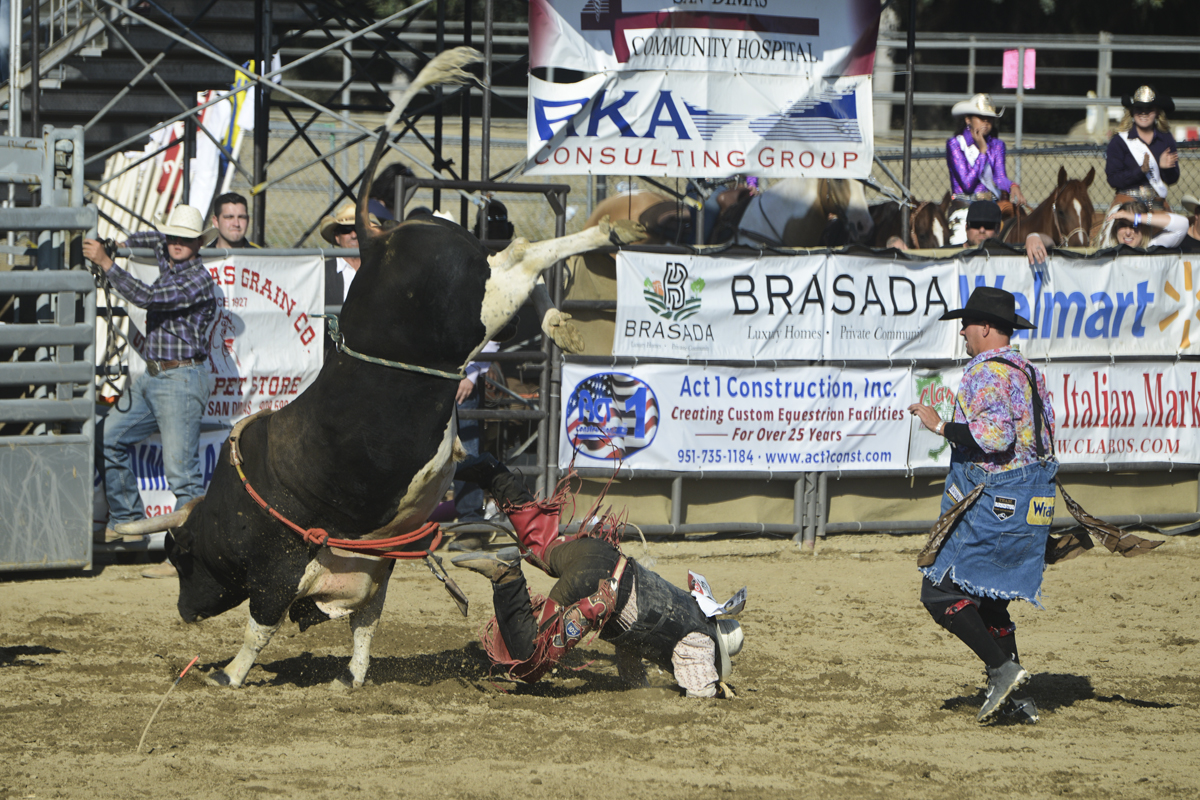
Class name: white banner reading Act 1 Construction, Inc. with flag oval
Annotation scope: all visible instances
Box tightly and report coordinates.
[559,363,912,471]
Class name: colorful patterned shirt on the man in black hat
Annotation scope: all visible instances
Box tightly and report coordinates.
[954,345,1054,473]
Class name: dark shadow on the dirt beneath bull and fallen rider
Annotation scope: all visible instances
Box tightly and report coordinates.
[248,642,625,697]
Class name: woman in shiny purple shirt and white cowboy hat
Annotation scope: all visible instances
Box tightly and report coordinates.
[946,95,1025,245]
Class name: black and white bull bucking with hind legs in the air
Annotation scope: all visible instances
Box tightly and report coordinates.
[121,48,644,687]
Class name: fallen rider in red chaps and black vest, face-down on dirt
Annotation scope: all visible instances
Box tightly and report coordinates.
[451,453,745,697]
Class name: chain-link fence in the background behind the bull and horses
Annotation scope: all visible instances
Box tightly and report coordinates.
[232,126,1200,247]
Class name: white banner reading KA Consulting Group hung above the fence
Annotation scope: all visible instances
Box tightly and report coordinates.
[526,72,874,178]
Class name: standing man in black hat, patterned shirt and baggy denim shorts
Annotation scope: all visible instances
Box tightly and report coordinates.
[908,287,1058,722]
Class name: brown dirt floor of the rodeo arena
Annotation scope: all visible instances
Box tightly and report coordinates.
[0,535,1200,800]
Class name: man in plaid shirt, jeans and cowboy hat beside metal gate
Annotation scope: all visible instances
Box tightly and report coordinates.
[83,205,217,568]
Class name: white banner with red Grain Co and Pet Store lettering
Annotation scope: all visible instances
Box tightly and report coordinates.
[128,255,325,426]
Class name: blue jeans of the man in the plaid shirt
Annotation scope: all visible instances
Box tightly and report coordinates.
[103,365,211,528]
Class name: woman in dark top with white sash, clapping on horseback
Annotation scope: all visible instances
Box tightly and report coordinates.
[1104,86,1180,211]
